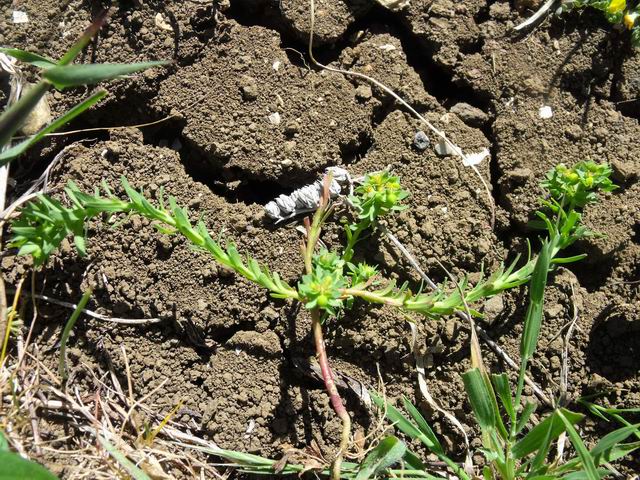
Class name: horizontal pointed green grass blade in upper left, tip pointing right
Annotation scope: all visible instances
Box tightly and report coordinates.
[42,62,168,90]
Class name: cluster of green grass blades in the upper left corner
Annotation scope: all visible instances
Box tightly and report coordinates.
[0,12,167,163]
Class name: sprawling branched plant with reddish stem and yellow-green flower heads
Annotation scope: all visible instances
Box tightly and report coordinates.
[7,162,613,478]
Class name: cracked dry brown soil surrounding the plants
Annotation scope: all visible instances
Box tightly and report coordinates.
[0,0,640,477]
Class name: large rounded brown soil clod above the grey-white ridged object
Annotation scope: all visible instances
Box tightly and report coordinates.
[155,20,371,185]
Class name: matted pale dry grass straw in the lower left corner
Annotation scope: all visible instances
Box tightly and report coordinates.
[0,306,226,480]
